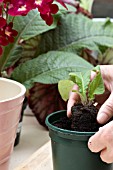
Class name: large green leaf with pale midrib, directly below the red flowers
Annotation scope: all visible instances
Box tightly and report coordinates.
[2,3,75,68]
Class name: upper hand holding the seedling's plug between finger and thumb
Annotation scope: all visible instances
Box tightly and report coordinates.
[67,65,113,124]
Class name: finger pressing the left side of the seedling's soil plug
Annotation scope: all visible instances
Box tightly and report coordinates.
[67,84,80,117]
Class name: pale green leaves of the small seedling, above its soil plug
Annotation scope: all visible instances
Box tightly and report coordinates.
[58,66,105,105]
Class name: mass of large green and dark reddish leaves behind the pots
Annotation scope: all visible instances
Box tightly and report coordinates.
[0,0,113,126]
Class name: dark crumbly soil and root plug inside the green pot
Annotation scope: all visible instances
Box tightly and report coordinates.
[54,104,101,132]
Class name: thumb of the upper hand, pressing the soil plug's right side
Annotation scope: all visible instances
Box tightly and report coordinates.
[97,92,113,124]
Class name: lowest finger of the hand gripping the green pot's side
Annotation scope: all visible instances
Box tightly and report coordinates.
[100,148,113,163]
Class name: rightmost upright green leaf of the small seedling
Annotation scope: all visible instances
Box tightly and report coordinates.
[88,67,105,101]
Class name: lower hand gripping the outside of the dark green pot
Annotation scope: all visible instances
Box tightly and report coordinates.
[88,121,113,163]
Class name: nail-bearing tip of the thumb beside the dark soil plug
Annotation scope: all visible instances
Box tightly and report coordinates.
[97,113,109,124]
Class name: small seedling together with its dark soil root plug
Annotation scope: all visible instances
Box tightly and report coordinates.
[57,66,105,132]
